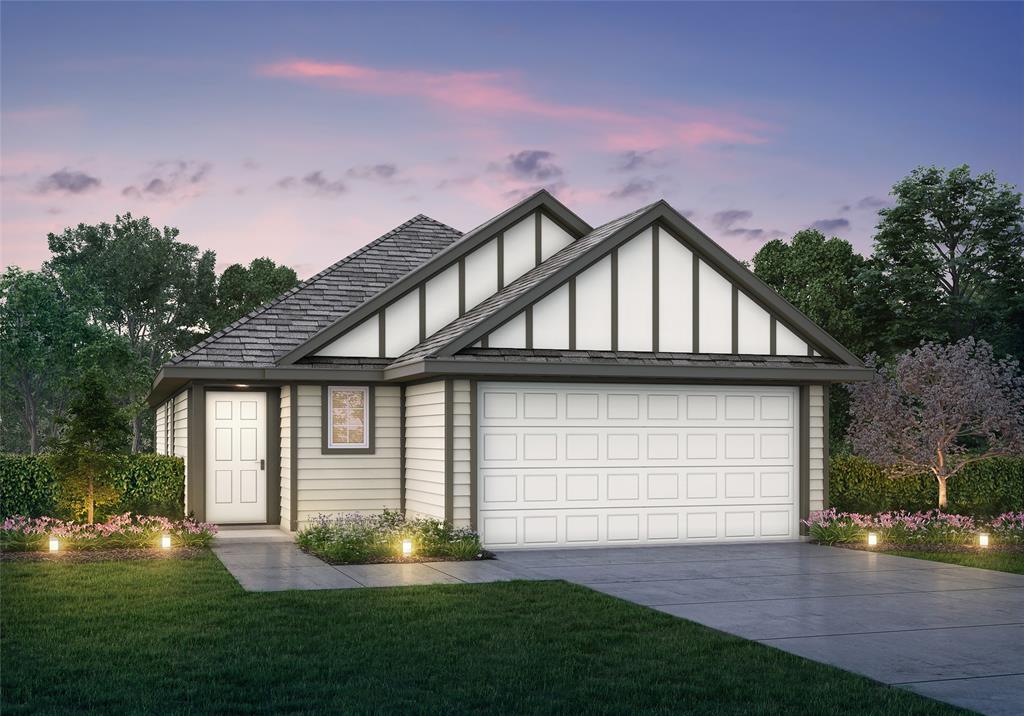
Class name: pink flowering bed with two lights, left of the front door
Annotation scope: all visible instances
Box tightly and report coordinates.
[0,512,217,552]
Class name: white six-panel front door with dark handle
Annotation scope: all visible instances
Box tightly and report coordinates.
[206,390,266,523]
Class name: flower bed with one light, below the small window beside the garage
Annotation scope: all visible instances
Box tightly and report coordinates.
[296,510,490,564]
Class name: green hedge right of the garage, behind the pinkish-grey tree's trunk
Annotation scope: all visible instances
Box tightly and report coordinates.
[828,455,1024,517]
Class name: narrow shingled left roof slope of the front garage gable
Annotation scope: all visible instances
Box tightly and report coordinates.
[394,202,656,365]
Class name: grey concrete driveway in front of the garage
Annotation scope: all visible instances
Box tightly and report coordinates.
[498,543,1024,714]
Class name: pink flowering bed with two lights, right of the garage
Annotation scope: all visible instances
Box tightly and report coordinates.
[803,509,1024,549]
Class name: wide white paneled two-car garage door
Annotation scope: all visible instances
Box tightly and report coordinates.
[477,383,799,549]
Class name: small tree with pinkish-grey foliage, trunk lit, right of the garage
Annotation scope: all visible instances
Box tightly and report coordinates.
[850,338,1024,509]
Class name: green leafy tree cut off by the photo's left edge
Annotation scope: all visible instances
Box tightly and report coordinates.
[0,266,97,454]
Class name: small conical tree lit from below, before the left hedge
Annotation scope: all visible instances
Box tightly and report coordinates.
[53,366,131,522]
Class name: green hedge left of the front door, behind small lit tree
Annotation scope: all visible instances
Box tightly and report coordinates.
[0,453,185,519]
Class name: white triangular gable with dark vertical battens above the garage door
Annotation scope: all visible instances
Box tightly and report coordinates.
[477,222,817,355]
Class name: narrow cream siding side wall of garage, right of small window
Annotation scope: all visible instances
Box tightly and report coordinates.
[406,380,446,519]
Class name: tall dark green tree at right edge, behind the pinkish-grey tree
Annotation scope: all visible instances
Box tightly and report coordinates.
[870,165,1024,354]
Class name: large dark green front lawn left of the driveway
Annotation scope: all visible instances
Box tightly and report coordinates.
[0,555,964,716]
